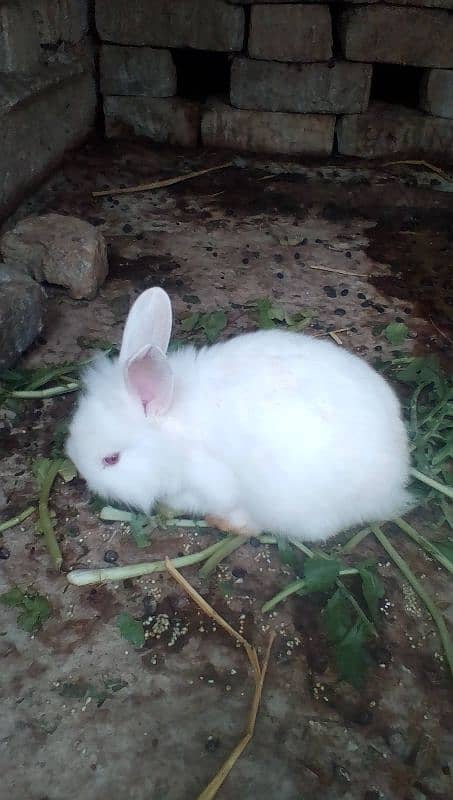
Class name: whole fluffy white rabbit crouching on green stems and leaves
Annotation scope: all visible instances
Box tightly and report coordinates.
[67,288,409,540]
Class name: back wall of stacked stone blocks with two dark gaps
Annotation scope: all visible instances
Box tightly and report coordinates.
[96,0,453,160]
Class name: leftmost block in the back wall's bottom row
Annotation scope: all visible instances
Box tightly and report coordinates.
[104,96,200,147]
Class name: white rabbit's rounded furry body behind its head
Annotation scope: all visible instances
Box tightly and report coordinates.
[171,331,409,538]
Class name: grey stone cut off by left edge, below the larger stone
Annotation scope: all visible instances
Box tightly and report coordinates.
[0,263,45,369]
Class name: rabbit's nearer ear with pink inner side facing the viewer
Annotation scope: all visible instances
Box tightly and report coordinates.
[124,345,173,416]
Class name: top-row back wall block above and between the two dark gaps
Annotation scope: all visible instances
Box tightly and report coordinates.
[248,4,332,61]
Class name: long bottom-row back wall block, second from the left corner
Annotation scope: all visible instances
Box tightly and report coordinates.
[201,101,335,156]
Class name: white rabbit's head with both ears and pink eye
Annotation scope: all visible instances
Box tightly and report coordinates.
[66,288,173,511]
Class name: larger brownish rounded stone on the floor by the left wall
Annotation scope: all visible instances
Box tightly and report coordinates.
[0,214,108,300]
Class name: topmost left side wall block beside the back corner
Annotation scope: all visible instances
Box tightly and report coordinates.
[33,0,89,44]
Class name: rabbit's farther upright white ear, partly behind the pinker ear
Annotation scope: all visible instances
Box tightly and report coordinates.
[120,286,172,363]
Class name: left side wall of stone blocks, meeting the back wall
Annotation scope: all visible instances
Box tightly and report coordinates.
[0,0,97,219]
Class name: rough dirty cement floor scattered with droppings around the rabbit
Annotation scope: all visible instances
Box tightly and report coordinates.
[0,142,453,800]
